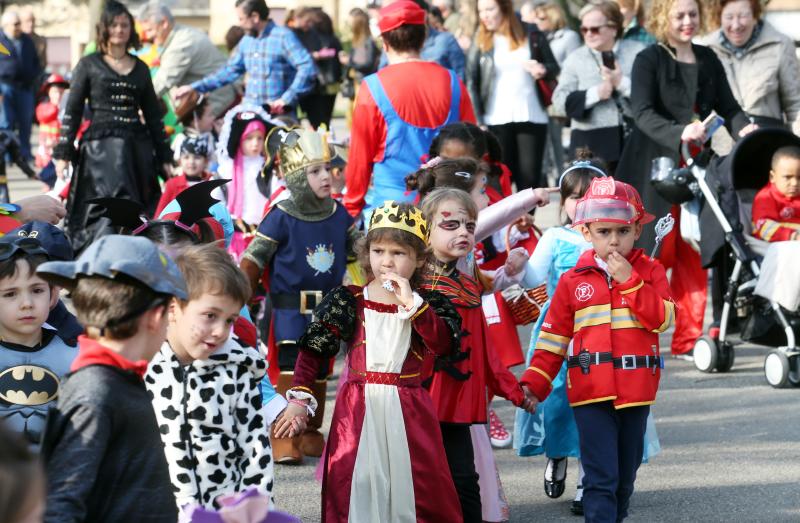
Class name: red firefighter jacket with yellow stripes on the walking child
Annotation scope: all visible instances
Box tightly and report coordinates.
[520,249,675,409]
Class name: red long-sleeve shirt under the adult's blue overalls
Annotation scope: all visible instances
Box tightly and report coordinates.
[344,62,475,216]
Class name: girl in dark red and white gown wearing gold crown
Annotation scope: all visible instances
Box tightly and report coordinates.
[275,202,462,523]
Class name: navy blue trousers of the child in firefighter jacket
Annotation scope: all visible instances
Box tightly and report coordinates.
[573,401,650,523]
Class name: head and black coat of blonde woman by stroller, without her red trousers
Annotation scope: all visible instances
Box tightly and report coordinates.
[617,0,751,249]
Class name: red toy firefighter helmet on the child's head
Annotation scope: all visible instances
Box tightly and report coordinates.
[573,176,655,225]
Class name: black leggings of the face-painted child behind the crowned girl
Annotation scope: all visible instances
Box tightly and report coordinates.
[439,423,483,523]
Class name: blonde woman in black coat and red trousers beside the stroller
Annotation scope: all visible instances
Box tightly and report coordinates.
[616,0,753,356]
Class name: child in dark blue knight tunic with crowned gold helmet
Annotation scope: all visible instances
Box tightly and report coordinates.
[241,128,358,463]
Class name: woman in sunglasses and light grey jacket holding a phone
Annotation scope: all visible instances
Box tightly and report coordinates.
[553,1,645,174]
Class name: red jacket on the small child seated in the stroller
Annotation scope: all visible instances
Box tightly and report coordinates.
[753,182,800,242]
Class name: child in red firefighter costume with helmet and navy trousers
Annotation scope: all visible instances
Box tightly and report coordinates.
[520,177,675,523]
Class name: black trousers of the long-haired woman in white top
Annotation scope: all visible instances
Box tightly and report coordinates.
[489,122,547,191]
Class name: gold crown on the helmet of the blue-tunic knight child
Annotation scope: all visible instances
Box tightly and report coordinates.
[264,127,331,176]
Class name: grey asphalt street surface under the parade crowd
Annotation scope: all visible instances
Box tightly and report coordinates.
[10,157,800,522]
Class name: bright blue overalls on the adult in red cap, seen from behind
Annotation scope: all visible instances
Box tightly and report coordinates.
[363,69,461,217]
